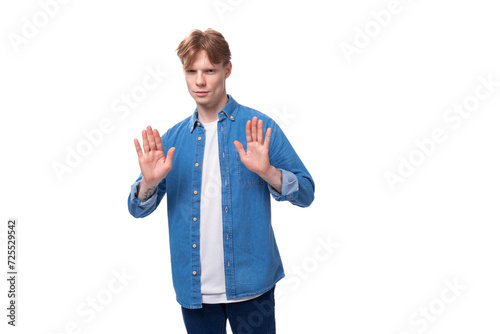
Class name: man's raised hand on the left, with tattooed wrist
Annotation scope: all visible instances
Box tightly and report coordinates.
[134,126,175,193]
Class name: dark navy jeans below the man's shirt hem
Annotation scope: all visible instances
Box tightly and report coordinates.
[182,287,276,334]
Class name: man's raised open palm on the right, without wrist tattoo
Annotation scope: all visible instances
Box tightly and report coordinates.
[234,117,271,177]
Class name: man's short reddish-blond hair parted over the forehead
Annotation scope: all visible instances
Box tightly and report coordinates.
[177,28,231,69]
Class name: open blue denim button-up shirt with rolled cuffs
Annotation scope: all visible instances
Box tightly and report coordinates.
[128,95,314,309]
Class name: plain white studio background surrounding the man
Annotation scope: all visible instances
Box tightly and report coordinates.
[0,0,500,334]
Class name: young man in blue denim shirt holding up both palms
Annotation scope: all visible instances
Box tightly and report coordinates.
[128,29,314,334]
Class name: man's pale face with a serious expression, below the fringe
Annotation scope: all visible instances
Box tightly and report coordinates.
[184,50,232,112]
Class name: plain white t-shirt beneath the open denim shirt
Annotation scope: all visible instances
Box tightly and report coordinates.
[200,121,258,304]
